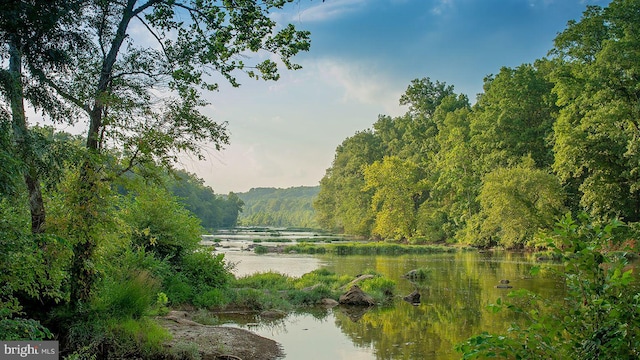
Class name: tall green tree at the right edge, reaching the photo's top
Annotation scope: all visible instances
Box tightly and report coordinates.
[551,0,640,222]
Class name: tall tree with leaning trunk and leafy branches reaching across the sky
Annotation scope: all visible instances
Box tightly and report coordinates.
[20,0,309,304]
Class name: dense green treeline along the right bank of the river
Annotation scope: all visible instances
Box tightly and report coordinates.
[315,1,640,248]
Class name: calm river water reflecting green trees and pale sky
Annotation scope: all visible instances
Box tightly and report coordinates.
[206,235,564,360]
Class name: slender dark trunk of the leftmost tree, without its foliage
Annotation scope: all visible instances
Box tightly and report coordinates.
[7,38,45,234]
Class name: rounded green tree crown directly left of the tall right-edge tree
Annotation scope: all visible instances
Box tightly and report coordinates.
[471,61,557,173]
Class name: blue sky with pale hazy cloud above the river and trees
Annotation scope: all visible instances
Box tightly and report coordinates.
[182,0,609,194]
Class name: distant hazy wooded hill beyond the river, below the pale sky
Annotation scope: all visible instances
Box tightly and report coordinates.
[236,186,320,228]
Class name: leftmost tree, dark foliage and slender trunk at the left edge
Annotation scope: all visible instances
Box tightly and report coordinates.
[0,0,83,234]
